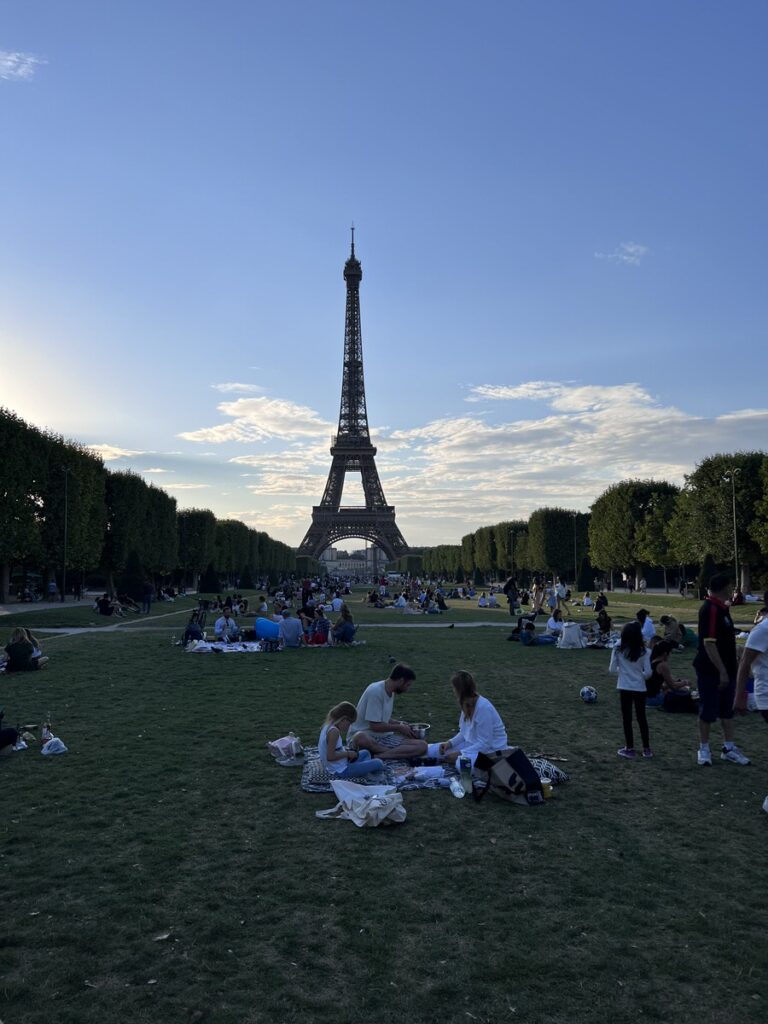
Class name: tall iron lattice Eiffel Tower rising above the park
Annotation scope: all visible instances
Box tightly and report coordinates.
[296,233,409,558]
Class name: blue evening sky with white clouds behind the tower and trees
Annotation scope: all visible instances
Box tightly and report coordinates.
[0,0,768,544]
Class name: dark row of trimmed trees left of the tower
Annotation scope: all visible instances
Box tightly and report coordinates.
[0,409,295,601]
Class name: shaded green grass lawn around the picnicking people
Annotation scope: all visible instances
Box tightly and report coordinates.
[0,595,768,1024]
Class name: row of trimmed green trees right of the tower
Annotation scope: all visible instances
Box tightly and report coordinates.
[421,452,768,593]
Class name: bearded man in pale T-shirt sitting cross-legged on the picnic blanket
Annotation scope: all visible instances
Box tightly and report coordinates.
[347,665,427,758]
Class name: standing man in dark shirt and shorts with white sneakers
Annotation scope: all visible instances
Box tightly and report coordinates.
[693,572,750,765]
